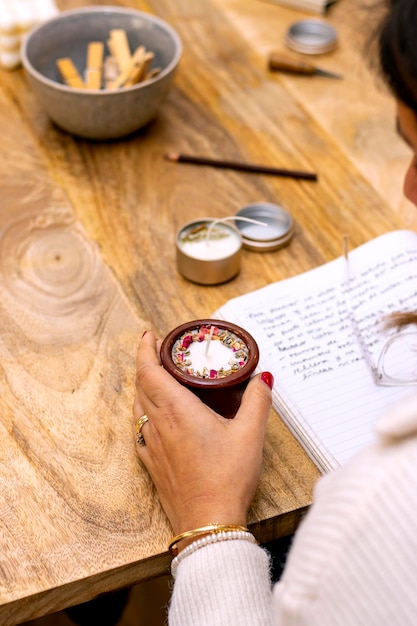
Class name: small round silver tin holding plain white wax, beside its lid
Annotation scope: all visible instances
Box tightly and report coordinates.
[176,217,242,285]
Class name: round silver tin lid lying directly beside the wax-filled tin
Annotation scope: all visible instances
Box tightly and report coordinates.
[235,202,294,252]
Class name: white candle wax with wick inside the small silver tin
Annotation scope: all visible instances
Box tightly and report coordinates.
[180,222,242,261]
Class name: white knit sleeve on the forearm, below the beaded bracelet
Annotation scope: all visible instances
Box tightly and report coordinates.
[169,539,273,626]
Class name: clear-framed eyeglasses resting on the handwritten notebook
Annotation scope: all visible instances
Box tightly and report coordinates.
[344,237,417,387]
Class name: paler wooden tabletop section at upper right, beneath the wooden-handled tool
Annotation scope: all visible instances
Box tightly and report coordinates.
[216,0,417,223]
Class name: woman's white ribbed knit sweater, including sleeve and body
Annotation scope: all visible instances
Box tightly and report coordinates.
[169,396,417,626]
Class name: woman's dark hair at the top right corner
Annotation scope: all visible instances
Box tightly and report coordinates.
[375,0,417,112]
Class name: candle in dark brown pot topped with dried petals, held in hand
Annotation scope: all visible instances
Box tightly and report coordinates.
[161,319,259,418]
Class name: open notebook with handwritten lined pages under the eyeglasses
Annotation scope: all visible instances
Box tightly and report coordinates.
[213,230,417,472]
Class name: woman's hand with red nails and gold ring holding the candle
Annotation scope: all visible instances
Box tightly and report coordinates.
[133,332,272,534]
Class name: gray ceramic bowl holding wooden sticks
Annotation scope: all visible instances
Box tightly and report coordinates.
[22,7,182,139]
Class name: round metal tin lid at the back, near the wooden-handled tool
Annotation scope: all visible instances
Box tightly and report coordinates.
[285,19,337,54]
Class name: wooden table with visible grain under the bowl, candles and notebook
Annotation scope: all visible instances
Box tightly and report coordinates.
[0,0,415,626]
